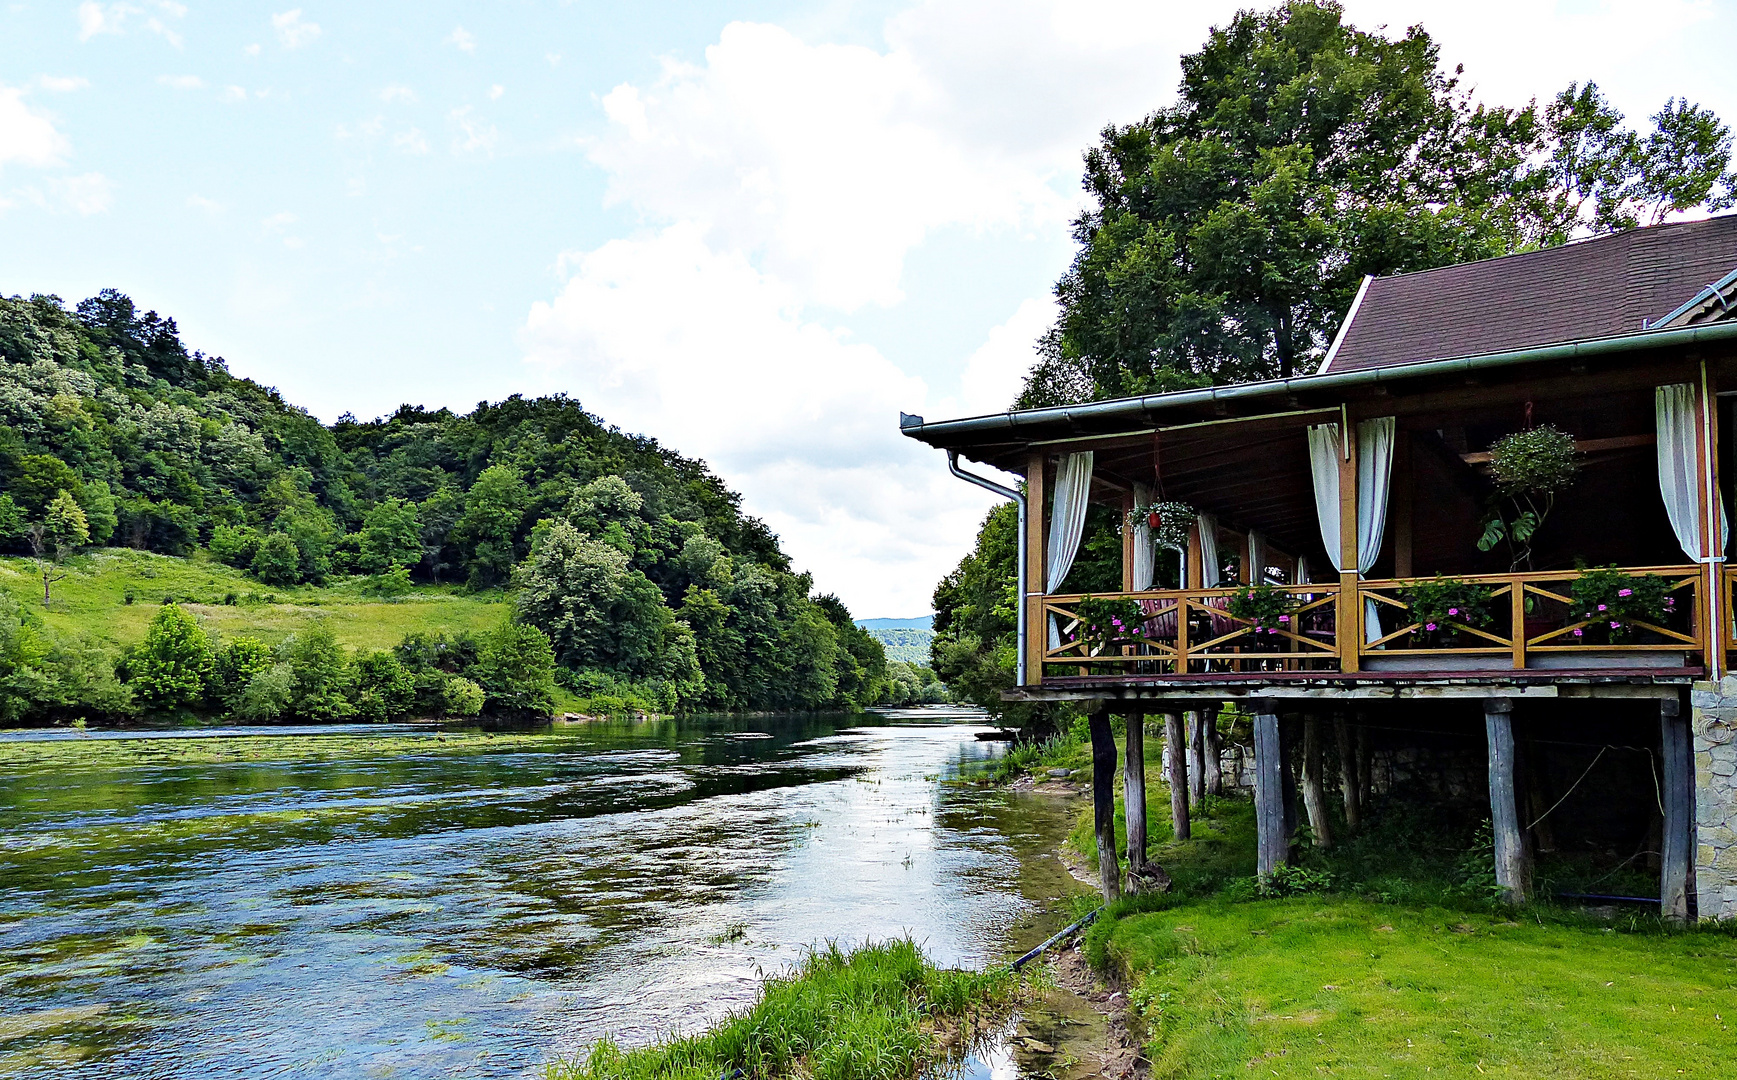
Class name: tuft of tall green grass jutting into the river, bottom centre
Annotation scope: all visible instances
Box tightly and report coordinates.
[547,938,1020,1080]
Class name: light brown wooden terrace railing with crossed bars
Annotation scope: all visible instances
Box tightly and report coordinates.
[1039,566,1702,679]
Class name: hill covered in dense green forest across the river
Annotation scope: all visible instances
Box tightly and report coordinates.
[0,290,886,722]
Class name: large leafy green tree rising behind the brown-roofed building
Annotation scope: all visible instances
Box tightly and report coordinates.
[1020,0,1734,406]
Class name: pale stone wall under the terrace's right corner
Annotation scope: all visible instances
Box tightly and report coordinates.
[1690,675,1737,919]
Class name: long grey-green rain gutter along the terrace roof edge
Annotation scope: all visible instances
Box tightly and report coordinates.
[900,323,1737,441]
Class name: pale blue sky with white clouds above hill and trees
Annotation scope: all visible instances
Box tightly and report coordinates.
[0,0,1737,618]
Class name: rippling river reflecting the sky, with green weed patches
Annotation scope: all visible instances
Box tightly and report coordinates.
[0,708,1075,1078]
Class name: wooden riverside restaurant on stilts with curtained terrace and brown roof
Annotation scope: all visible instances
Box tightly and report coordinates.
[900,215,1737,919]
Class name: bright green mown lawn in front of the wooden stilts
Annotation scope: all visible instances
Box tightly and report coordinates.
[1018,722,1737,1080]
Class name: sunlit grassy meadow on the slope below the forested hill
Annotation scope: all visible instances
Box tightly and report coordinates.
[0,547,509,649]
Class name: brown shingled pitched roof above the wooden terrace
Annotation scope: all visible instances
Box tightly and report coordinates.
[1322,214,1737,373]
